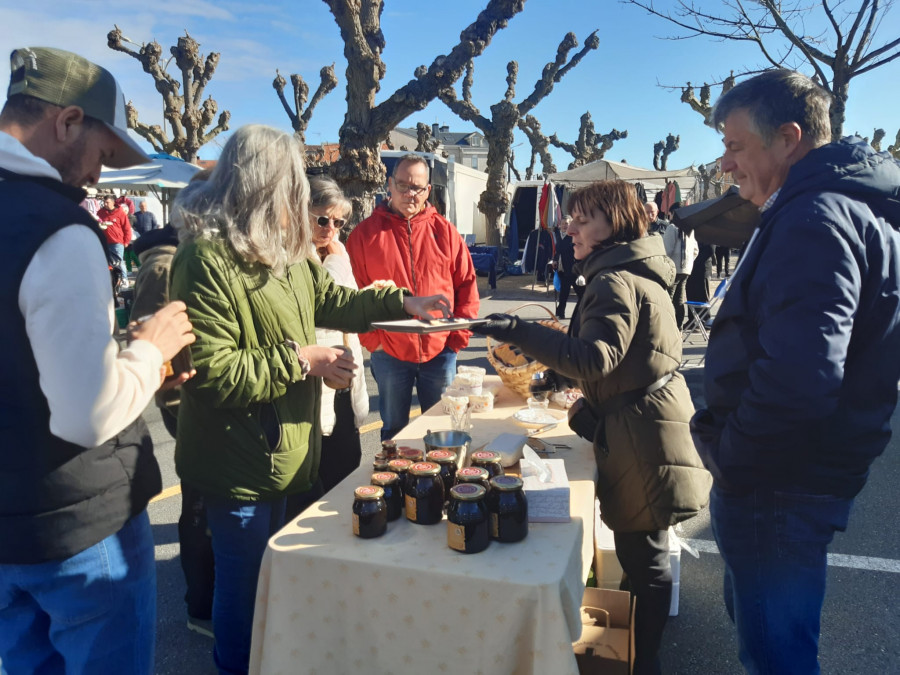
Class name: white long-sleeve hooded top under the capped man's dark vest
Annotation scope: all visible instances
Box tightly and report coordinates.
[0,132,162,447]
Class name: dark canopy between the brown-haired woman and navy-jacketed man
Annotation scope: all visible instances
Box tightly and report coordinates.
[673,185,759,248]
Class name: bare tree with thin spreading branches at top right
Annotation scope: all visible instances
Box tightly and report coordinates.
[625,0,900,141]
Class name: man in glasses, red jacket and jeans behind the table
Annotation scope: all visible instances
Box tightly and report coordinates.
[347,154,478,440]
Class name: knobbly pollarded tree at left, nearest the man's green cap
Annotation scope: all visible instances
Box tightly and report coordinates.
[106,26,231,162]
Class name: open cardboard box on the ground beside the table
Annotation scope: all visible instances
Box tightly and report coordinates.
[572,588,634,675]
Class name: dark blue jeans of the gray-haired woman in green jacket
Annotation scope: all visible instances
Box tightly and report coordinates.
[206,497,287,673]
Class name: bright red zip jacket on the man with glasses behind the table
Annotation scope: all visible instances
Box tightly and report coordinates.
[347,203,478,363]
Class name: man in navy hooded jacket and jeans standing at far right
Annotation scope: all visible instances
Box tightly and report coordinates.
[692,70,900,674]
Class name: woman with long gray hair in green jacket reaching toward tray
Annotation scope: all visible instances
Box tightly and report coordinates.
[171,125,449,673]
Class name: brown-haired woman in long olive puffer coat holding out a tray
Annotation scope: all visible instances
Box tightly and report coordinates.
[473,181,711,675]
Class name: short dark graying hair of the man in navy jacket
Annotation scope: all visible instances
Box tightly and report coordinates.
[712,68,831,147]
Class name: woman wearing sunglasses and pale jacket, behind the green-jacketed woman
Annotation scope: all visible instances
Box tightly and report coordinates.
[309,176,369,492]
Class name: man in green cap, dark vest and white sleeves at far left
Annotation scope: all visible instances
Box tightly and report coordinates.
[0,47,194,674]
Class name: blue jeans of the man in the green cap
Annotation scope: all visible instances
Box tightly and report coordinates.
[0,511,156,675]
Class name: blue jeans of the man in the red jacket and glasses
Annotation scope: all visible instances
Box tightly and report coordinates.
[370,349,456,441]
